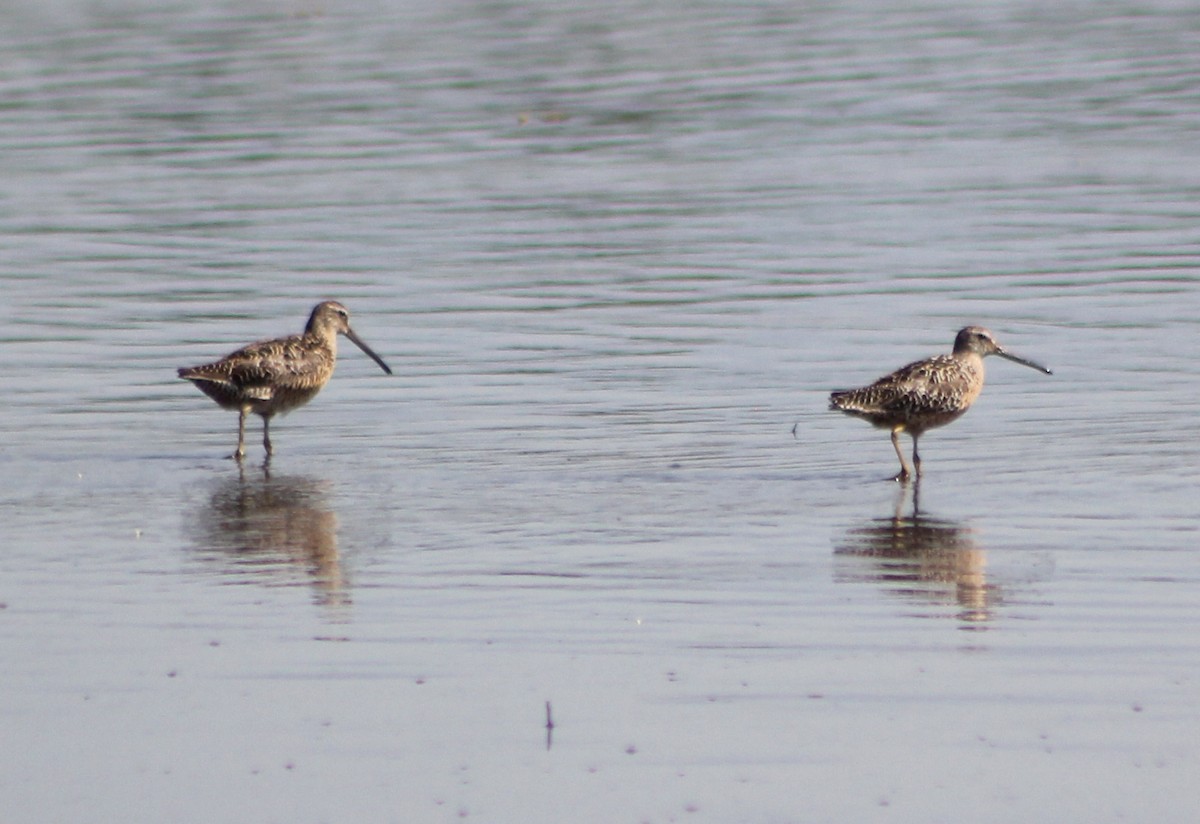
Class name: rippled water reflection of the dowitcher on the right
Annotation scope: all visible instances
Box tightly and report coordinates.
[834,486,1001,628]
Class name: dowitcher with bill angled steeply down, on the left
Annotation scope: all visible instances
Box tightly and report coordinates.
[179,300,391,461]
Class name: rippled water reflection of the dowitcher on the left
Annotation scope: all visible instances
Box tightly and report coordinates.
[186,464,350,607]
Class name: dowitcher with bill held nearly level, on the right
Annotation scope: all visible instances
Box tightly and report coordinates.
[829,326,1051,481]
